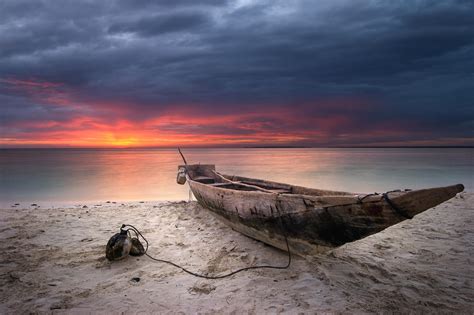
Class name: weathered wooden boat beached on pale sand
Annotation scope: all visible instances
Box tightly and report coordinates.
[178,164,464,256]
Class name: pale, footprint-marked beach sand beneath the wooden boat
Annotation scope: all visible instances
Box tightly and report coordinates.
[0,193,474,314]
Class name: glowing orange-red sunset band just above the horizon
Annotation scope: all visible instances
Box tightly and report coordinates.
[0,79,469,148]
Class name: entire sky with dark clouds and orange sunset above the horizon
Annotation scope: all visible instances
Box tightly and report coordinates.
[0,0,474,148]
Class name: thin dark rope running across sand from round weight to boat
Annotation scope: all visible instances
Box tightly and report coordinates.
[122,211,291,280]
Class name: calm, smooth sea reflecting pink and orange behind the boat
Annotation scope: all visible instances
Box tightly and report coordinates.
[0,148,474,202]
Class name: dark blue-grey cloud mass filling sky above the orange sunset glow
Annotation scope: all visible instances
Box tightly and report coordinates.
[0,0,474,146]
